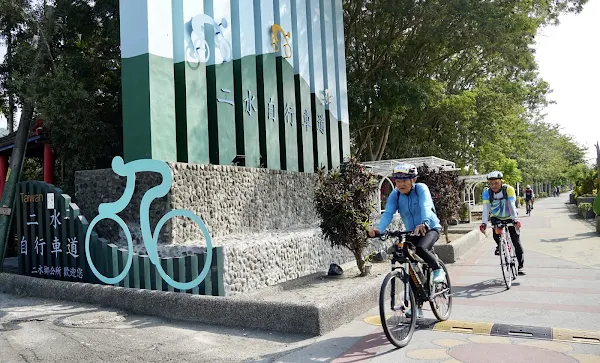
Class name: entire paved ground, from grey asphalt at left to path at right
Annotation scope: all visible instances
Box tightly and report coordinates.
[0,196,600,363]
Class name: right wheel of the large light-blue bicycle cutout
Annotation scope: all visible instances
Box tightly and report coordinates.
[146,209,213,291]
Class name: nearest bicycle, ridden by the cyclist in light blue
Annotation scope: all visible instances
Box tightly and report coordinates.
[379,231,452,348]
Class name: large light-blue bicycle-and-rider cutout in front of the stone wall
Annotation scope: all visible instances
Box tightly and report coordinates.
[85,156,213,291]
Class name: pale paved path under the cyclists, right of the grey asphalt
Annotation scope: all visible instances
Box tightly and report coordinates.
[263,195,600,363]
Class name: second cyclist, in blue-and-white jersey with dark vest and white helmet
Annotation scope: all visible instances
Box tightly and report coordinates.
[479,171,525,275]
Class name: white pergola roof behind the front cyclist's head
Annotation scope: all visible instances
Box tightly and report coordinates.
[361,156,460,212]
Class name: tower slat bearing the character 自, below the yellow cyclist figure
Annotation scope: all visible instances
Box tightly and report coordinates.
[254,0,281,169]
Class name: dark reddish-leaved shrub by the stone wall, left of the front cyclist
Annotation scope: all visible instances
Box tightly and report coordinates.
[314,158,378,276]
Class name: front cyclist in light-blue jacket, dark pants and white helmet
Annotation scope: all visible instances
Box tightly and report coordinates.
[369,164,446,317]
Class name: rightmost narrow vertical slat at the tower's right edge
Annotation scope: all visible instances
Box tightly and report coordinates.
[333,0,350,158]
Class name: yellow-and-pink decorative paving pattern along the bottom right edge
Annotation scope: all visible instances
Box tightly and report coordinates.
[406,335,600,363]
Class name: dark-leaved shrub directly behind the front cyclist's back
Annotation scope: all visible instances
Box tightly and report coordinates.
[418,165,465,243]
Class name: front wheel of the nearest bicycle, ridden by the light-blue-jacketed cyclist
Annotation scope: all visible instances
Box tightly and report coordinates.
[379,269,417,348]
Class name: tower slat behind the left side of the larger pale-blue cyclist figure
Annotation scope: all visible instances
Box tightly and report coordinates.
[173,0,210,164]
